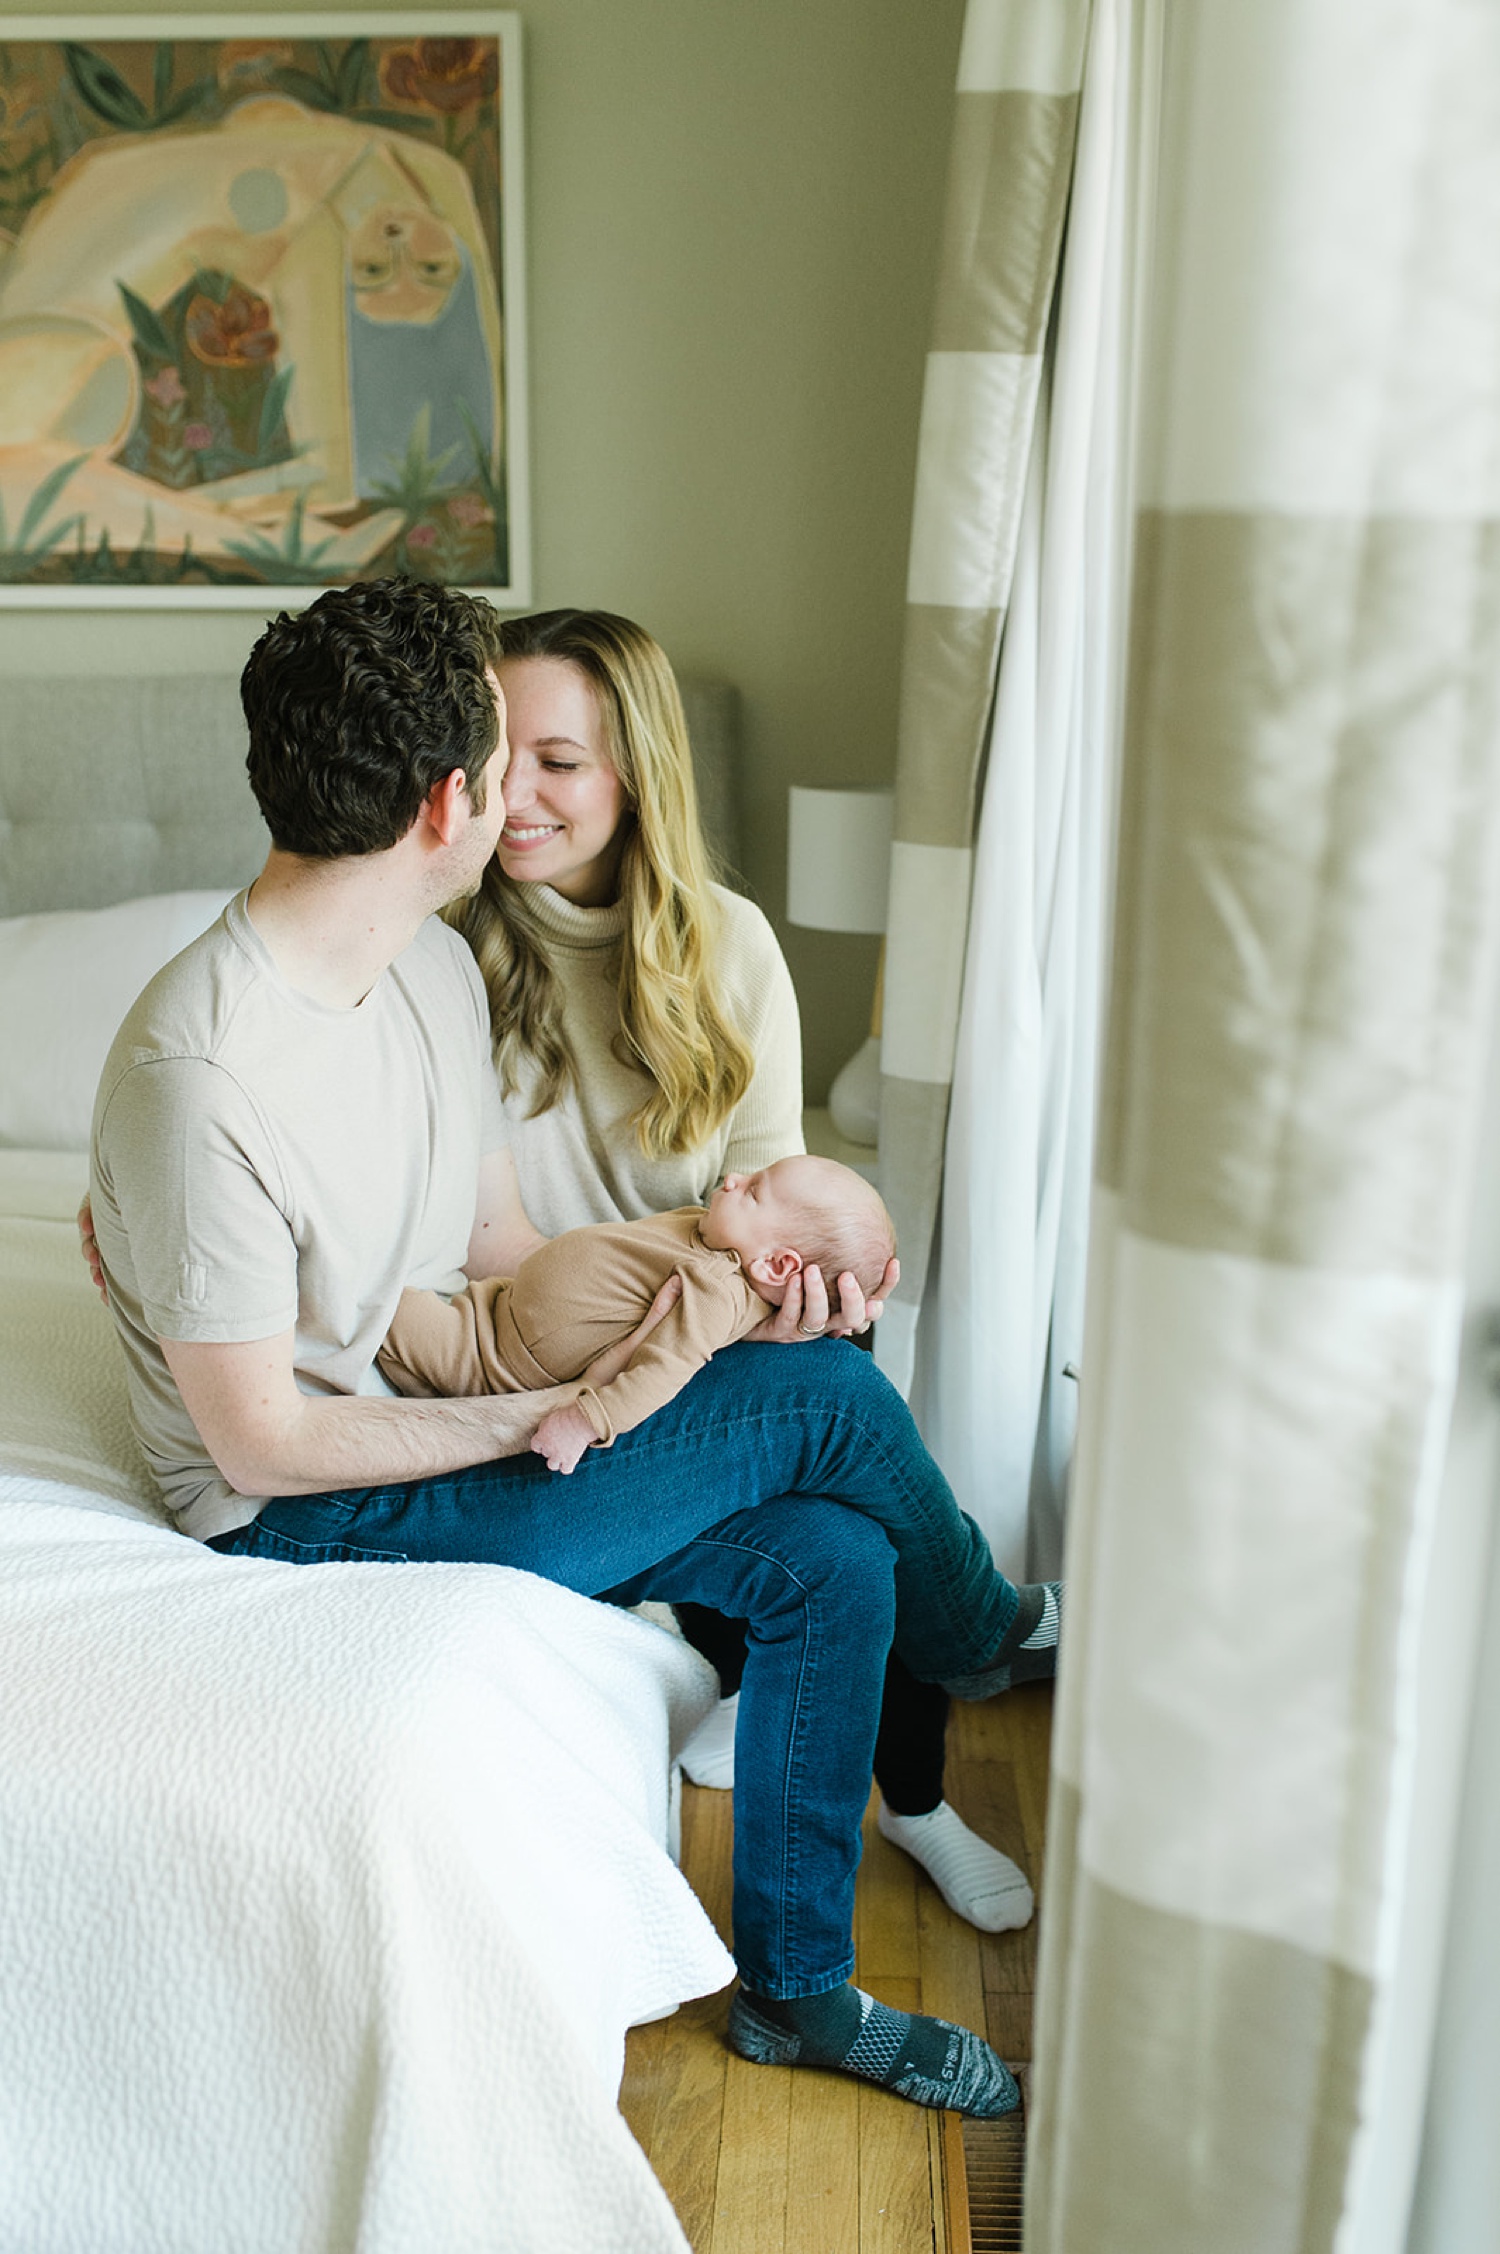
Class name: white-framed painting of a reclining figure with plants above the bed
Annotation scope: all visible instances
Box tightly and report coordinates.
[0,11,530,609]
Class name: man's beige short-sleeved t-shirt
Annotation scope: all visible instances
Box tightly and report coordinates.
[90,893,505,1539]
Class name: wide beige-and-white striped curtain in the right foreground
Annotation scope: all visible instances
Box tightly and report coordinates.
[1024,0,1500,2254]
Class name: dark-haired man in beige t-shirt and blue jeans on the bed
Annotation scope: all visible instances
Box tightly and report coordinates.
[92,582,1056,2114]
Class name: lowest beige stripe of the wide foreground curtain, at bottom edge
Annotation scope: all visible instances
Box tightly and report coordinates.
[1026,1830,1374,2254]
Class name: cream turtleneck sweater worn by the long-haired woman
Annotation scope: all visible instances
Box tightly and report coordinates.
[493,884,803,1237]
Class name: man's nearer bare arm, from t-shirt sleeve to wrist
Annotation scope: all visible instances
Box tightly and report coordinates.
[160,1330,577,1494]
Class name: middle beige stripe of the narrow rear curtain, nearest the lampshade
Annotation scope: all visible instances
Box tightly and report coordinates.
[895,602,1006,845]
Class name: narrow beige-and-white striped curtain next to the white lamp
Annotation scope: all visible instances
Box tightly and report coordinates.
[875,0,1089,1393]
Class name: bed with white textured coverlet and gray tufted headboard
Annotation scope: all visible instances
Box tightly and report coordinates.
[0,681,733,2254]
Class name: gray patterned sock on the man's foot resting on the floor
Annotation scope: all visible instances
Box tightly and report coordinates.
[729,1986,1022,2121]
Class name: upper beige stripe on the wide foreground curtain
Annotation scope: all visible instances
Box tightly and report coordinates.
[1098,512,1500,1276]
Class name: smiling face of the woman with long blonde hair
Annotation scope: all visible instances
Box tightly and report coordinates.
[496,658,627,908]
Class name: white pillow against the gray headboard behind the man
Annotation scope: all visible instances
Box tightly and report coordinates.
[0,893,235,1150]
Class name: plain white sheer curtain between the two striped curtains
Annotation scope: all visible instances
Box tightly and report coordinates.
[888,0,1136,1580]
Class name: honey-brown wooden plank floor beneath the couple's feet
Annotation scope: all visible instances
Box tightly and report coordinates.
[620,1684,1051,2254]
